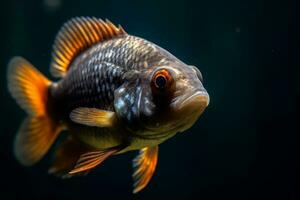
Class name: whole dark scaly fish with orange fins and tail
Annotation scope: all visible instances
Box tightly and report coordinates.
[7,17,210,193]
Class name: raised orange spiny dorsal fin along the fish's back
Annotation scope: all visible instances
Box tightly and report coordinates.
[50,17,126,77]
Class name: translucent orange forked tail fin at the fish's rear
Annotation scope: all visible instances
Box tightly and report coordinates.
[7,57,61,166]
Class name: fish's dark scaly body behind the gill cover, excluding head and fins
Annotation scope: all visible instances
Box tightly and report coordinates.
[50,35,180,152]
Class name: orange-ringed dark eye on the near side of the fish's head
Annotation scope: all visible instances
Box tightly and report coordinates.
[152,69,173,89]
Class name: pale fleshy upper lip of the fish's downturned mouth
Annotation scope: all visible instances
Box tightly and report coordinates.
[178,90,210,109]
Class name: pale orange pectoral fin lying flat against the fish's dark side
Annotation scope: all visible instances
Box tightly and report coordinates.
[70,108,116,127]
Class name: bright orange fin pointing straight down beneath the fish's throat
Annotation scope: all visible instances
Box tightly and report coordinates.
[132,146,158,193]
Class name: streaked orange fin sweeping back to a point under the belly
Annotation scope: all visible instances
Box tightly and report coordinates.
[69,148,120,174]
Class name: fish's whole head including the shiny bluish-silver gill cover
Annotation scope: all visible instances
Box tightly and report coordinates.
[114,62,209,137]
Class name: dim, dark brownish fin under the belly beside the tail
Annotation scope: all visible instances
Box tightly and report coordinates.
[48,136,91,178]
